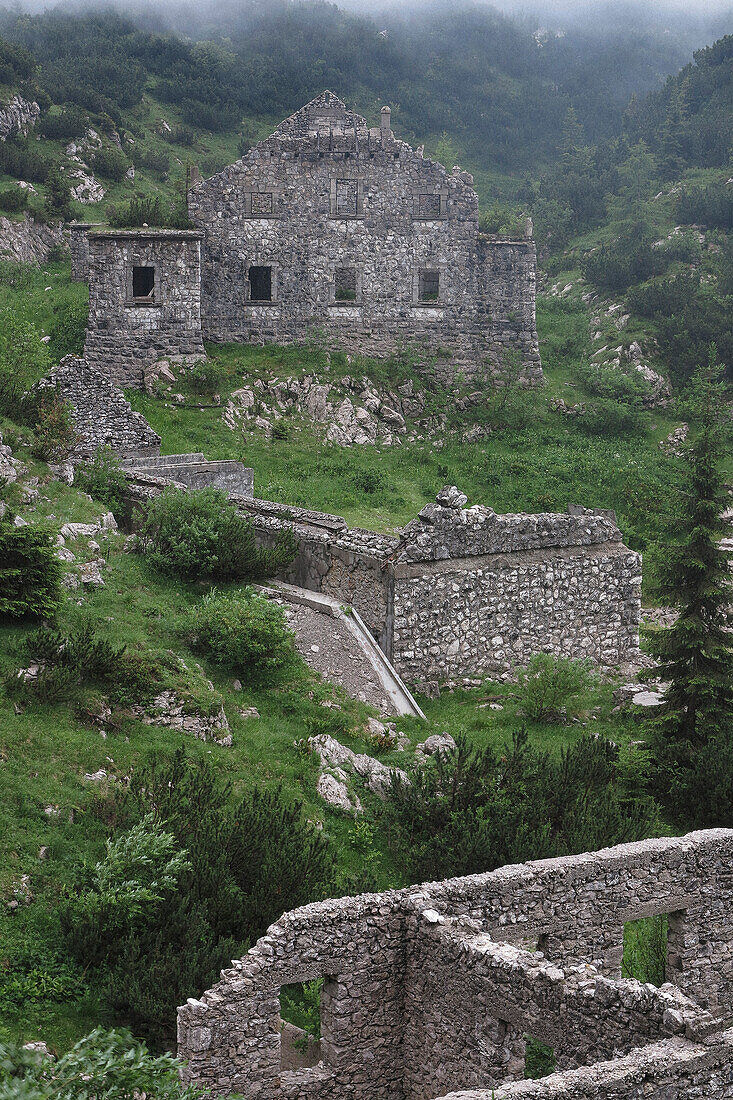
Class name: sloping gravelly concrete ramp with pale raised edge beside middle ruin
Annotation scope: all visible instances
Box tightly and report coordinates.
[259,582,425,718]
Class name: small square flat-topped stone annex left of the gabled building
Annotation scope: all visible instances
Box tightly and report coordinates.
[84,229,205,388]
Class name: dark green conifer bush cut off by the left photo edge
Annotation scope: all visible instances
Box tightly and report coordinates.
[0,514,62,618]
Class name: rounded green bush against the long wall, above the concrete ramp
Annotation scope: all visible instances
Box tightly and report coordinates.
[140,488,295,581]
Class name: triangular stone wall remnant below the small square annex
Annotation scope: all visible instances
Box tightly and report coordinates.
[41,355,161,458]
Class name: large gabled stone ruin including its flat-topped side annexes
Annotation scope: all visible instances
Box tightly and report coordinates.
[77,91,541,386]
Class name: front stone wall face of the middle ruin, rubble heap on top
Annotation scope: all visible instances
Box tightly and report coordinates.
[390,487,642,681]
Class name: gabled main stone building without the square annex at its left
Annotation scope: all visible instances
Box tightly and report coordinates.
[183,91,541,383]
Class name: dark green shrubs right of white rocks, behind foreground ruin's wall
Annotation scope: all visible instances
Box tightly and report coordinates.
[384,733,660,882]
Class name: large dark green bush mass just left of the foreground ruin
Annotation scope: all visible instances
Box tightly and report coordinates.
[77,749,333,1044]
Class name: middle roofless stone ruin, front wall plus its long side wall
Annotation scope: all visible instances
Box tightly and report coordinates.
[122,486,642,683]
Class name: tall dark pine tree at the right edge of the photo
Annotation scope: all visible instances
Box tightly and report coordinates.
[650,349,733,825]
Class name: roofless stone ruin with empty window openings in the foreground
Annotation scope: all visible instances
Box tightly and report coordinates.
[178,829,733,1100]
